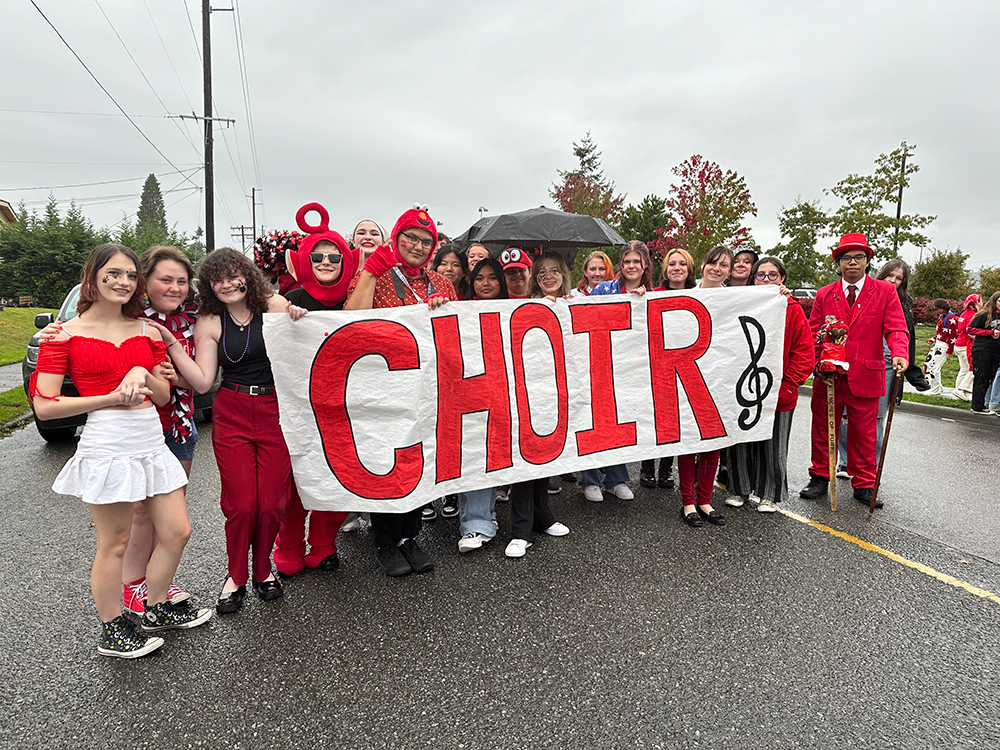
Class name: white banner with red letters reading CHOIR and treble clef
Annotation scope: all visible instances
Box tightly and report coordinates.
[264,286,787,512]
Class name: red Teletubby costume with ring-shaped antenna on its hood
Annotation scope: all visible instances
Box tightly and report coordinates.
[274,203,359,577]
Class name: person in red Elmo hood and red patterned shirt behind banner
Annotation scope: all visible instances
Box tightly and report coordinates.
[344,205,458,577]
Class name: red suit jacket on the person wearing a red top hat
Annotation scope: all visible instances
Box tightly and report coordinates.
[809,276,910,398]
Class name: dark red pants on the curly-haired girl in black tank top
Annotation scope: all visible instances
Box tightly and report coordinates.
[212,388,292,586]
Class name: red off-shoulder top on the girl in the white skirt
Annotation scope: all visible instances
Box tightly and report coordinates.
[29,336,167,400]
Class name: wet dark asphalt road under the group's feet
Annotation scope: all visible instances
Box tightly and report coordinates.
[0,399,1000,748]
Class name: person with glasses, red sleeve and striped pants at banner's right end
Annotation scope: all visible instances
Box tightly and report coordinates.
[726,256,816,513]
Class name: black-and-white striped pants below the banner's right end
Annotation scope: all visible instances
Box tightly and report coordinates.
[726,409,795,503]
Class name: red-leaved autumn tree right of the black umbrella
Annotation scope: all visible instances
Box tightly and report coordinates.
[649,154,758,266]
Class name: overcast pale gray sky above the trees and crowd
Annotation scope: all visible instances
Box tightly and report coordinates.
[0,0,1000,269]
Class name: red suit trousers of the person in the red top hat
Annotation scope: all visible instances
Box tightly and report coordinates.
[809,376,879,489]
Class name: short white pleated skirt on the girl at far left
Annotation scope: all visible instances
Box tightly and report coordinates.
[52,409,187,505]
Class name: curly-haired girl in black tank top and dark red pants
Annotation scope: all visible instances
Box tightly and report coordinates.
[151,247,305,614]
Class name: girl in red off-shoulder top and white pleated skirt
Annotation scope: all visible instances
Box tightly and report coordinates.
[31,244,212,658]
